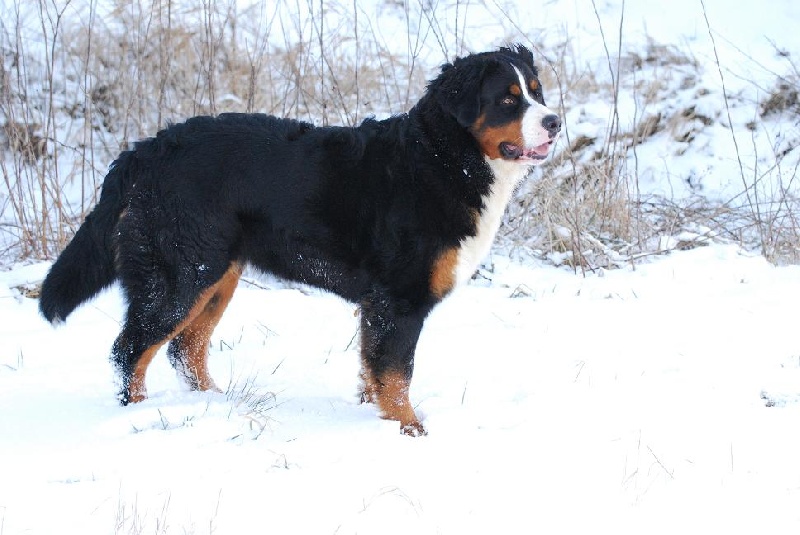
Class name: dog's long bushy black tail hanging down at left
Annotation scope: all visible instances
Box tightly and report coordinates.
[39,151,136,323]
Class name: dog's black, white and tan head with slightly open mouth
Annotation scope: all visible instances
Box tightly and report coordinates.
[429,45,561,165]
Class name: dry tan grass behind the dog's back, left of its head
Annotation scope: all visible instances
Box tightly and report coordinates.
[0,0,432,263]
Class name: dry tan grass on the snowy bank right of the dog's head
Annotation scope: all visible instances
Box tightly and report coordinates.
[503,12,800,270]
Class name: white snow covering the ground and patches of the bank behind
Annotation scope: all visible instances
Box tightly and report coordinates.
[0,0,800,535]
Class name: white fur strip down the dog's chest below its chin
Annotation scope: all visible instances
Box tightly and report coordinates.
[455,158,528,284]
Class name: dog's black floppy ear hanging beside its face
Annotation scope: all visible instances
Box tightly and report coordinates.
[429,58,487,128]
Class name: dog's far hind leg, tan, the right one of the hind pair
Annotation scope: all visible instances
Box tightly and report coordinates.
[167,263,242,390]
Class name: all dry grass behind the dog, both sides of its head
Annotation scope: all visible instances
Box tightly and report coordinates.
[0,0,800,269]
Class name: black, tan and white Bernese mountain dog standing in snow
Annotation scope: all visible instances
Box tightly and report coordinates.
[40,45,561,435]
